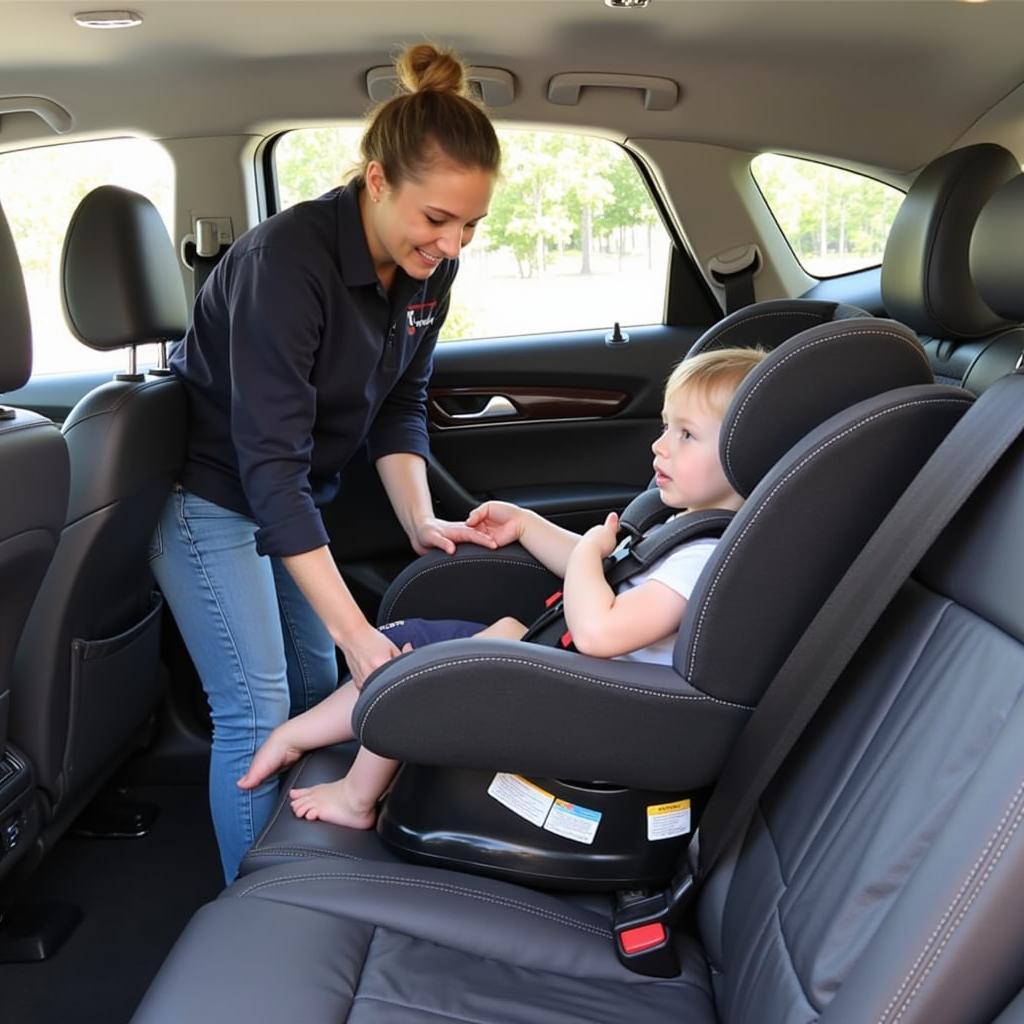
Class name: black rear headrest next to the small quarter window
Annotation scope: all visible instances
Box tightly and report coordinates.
[882,142,1020,339]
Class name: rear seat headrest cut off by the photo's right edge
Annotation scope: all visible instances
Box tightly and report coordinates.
[971,174,1024,323]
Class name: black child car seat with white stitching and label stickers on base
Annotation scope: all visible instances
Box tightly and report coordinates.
[355,318,972,889]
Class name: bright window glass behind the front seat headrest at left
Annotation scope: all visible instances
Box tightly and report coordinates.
[0,138,174,376]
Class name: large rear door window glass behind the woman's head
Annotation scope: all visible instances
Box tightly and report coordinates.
[273,127,671,341]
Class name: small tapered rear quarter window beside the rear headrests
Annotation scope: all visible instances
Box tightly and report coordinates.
[751,153,903,278]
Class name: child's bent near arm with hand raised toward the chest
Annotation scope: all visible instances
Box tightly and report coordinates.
[563,513,686,657]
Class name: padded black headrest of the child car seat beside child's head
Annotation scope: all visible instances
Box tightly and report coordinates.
[719,316,934,498]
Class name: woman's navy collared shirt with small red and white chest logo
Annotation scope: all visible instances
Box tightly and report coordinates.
[170,183,458,555]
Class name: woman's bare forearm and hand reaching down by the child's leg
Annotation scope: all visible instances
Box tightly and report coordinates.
[282,547,398,687]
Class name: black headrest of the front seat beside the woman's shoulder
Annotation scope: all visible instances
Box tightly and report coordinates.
[61,185,188,350]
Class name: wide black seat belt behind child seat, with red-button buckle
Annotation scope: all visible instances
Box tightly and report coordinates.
[612,371,1024,978]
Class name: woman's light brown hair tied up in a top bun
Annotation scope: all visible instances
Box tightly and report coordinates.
[359,43,502,187]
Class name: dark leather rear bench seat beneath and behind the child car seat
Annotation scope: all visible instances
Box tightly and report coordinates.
[134,183,1024,1024]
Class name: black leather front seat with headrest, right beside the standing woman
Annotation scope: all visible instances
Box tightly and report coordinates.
[11,185,188,843]
